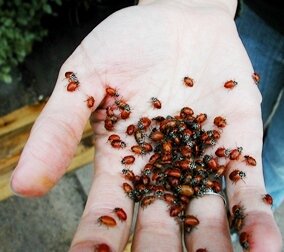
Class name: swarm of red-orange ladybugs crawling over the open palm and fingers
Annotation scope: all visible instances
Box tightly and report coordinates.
[65,72,268,252]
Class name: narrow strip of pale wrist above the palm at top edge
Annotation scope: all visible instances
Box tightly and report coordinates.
[138,0,238,17]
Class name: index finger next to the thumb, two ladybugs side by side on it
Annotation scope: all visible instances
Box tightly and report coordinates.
[70,137,133,252]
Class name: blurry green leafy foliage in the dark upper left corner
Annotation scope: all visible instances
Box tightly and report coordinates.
[0,0,62,83]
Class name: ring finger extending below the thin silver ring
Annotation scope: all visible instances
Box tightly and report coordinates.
[185,195,233,251]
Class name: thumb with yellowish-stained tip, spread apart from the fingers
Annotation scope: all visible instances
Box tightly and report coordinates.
[11,46,104,196]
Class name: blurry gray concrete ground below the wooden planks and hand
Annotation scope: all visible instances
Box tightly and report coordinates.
[0,165,284,252]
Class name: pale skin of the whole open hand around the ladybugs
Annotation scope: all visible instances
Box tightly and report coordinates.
[11,0,282,252]
